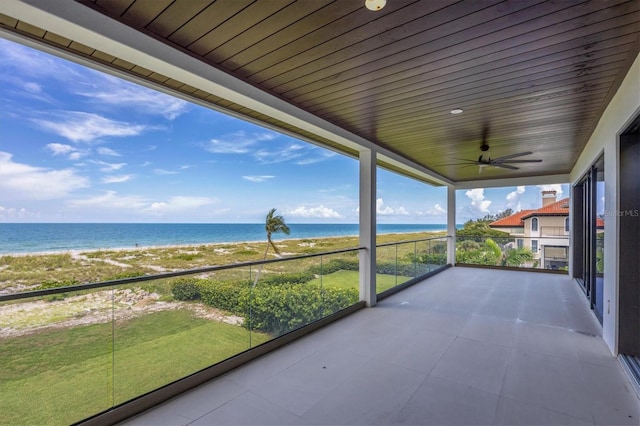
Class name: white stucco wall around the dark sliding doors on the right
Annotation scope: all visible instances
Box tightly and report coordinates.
[570,51,640,354]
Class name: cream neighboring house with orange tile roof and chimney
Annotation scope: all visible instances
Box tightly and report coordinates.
[489,191,570,269]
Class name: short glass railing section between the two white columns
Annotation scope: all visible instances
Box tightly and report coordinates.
[376,237,447,294]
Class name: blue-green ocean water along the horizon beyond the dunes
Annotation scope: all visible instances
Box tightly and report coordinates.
[0,223,446,254]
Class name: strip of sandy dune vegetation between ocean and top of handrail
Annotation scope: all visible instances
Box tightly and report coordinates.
[0,232,444,294]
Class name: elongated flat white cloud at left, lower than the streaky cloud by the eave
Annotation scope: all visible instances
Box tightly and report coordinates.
[33,111,147,142]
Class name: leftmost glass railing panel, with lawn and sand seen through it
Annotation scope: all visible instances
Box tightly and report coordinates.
[0,288,114,425]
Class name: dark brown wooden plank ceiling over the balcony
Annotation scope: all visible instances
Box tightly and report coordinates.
[5,0,640,181]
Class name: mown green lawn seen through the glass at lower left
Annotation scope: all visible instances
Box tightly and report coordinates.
[0,310,269,425]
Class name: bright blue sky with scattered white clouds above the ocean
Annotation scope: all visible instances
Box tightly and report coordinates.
[0,39,568,223]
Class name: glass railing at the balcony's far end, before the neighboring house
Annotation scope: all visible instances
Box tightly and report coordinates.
[456,235,569,271]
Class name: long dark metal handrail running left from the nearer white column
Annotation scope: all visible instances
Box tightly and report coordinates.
[0,247,365,302]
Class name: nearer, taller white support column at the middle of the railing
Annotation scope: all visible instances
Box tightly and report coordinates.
[360,150,377,307]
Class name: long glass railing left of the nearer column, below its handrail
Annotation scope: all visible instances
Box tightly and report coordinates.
[0,249,360,425]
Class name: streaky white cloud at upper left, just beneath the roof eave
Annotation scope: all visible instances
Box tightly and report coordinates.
[78,75,189,120]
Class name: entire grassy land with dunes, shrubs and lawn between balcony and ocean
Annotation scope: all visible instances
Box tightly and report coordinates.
[0,233,441,424]
